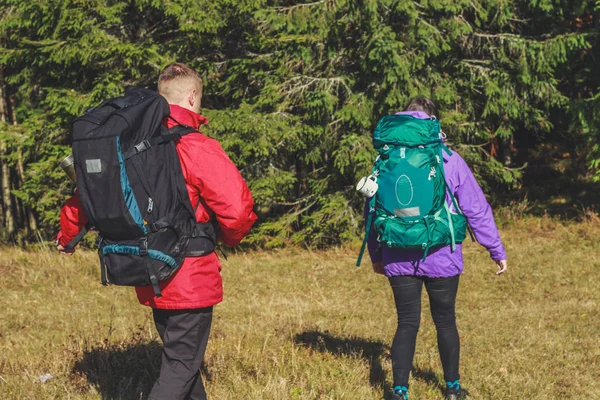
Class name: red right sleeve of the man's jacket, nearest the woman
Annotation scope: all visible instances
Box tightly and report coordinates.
[178,139,257,246]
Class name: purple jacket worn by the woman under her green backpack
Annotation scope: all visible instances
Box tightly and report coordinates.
[367,111,506,278]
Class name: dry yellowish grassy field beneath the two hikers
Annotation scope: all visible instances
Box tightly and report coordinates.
[0,215,600,400]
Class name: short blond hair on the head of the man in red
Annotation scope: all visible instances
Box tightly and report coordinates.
[158,63,202,103]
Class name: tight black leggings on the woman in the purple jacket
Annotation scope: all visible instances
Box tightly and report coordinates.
[390,275,460,386]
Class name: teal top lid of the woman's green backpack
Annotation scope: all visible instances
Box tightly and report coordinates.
[373,115,441,149]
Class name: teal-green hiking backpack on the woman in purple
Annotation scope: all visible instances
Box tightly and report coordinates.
[356,115,467,266]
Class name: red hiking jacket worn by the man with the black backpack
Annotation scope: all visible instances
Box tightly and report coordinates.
[57,104,256,310]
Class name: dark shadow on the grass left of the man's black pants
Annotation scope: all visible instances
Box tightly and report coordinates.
[73,341,162,400]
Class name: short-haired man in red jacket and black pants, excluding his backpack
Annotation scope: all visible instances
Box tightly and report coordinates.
[57,63,256,400]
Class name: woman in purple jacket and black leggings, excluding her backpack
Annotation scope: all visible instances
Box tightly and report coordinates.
[368,97,507,400]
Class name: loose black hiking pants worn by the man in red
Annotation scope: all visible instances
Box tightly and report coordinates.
[148,307,213,400]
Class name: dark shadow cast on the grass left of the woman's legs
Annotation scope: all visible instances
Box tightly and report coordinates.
[294,331,392,394]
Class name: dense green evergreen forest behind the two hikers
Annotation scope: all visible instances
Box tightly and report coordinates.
[0,0,600,248]
